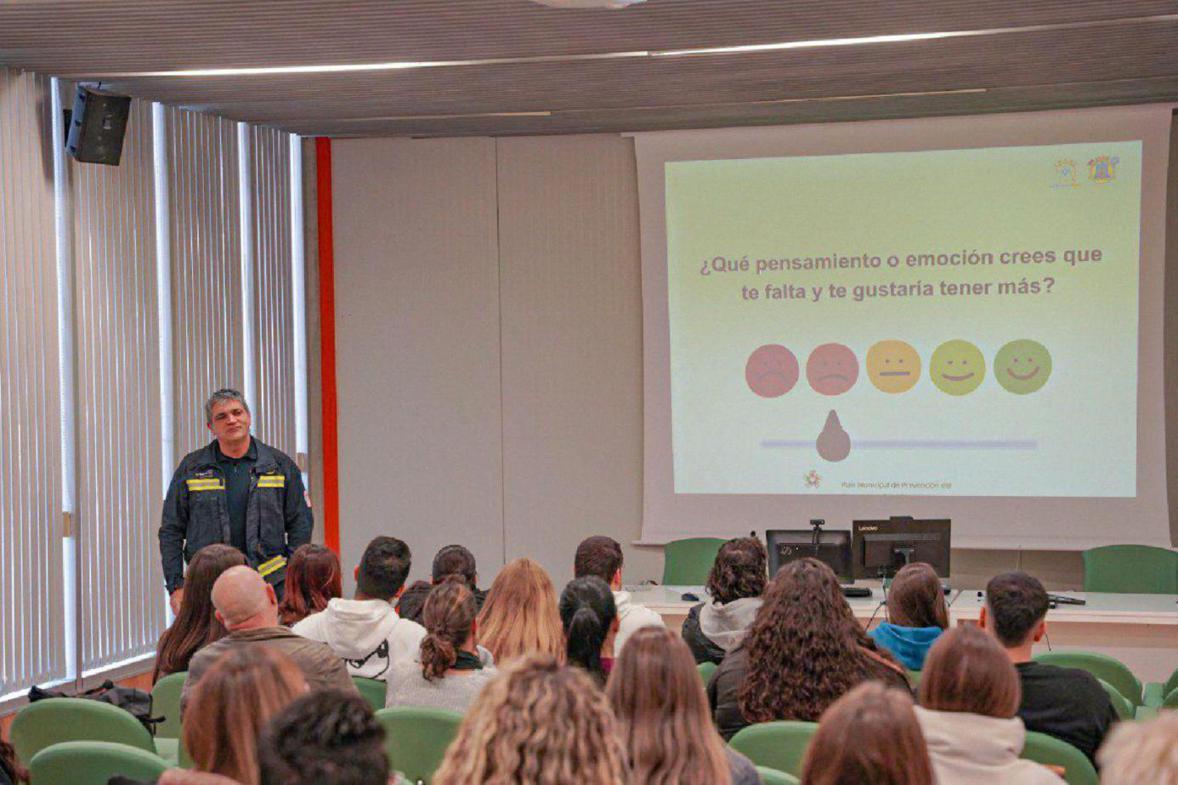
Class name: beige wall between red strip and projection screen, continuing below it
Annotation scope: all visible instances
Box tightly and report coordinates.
[332,134,1173,588]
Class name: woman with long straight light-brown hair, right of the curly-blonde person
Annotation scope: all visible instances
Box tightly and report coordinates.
[605,627,761,785]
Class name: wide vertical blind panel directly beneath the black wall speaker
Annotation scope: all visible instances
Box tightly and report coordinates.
[67,101,164,671]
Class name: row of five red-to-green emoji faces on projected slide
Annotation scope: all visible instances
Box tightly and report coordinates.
[744,338,1051,398]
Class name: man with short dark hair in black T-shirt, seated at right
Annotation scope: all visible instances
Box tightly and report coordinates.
[979,572,1117,761]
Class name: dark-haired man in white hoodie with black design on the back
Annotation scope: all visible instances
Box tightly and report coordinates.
[293,536,425,680]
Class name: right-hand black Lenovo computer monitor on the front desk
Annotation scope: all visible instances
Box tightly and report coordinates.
[851,517,949,579]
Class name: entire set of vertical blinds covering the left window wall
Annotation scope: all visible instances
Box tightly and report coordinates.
[0,68,305,695]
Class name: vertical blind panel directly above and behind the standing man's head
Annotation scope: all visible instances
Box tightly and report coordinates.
[166,103,245,461]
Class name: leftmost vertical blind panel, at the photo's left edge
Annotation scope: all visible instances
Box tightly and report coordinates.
[0,68,66,694]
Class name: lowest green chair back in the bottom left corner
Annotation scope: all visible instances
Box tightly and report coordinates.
[28,741,167,785]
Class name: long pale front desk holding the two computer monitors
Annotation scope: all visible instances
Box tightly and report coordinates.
[630,582,1178,681]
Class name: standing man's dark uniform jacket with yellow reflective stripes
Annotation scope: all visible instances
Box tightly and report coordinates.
[159,438,312,593]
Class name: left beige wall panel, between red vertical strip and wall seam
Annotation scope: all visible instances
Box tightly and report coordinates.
[332,139,503,576]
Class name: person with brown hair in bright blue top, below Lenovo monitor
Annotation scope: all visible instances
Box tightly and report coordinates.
[871,562,949,671]
